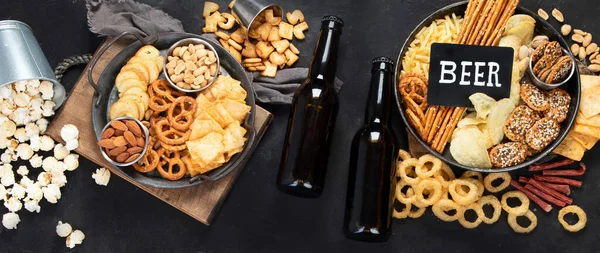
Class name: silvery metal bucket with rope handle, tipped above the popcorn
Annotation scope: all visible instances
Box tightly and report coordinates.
[0,20,66,109]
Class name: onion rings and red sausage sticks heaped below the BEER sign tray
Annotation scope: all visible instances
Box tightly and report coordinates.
[393,150,587,233]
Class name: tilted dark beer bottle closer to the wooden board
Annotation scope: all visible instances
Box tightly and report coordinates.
[277,16,344,198]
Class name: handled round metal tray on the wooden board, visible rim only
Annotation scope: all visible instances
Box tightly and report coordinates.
[88,33,256,188]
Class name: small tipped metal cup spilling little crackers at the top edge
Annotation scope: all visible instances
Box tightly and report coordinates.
[231,0,283,39]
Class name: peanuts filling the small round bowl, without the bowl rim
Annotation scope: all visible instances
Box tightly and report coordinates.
[165,43,218,90]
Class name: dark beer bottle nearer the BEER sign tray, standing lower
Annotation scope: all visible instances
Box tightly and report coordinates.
[343,57,396,241]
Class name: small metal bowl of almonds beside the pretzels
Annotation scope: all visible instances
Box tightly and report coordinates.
[98,116,148,167]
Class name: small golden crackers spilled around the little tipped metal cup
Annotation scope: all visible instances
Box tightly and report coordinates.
[202,0,308,77]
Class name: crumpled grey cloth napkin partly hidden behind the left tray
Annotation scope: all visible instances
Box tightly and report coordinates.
[86,0,344,104]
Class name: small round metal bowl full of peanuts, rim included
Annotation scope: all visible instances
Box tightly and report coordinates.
[163,38,221,93]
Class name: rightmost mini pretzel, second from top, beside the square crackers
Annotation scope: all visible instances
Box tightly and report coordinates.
[167,96,197,131]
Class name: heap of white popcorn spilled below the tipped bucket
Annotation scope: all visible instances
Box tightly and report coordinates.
[0,80,85,232]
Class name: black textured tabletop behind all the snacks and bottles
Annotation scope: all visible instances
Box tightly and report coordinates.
[0,0,600,252]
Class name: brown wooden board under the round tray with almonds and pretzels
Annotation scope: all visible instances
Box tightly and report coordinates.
[46,40,273,225]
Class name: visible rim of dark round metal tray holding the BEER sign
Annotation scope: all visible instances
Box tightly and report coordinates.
[394,1,581,172]
